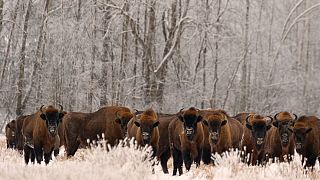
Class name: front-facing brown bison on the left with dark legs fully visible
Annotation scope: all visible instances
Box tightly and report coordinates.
[22,105,64,164]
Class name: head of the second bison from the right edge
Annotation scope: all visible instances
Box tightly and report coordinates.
[272,112,297,147]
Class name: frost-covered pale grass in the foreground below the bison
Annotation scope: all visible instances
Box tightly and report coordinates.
[0,135,320,180]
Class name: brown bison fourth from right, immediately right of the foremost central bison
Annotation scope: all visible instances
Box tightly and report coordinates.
[202,110,243,163]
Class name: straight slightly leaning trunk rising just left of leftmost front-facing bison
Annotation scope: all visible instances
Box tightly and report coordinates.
[16,0,32,116]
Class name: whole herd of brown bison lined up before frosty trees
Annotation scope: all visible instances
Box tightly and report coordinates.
[5,105,320,175]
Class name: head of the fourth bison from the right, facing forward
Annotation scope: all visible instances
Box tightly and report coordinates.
[202,113,228,144]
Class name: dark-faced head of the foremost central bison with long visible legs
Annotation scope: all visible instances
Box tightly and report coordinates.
[178,107,202,141]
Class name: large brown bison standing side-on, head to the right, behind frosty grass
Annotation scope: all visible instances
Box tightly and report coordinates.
[62,106,133,156]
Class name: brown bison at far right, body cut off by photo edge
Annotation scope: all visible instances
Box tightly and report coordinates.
[290,116,320,167]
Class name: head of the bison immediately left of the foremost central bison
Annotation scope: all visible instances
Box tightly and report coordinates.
[134,109,159,145]
